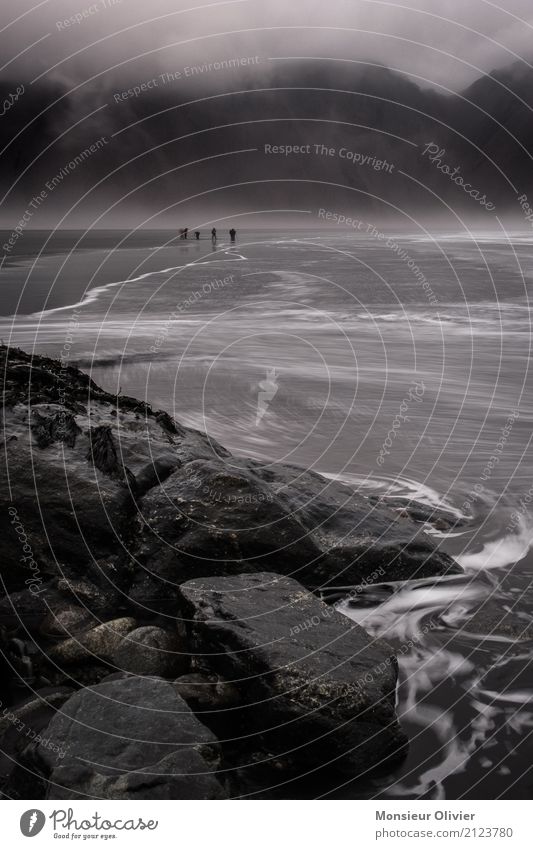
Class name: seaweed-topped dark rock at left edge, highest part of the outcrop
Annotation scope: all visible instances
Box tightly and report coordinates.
[0,346,228,591]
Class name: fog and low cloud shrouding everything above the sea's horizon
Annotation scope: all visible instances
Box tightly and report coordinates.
[0,0,533,230]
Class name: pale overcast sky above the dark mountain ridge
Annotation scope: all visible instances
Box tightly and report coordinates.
[0,0,533,90]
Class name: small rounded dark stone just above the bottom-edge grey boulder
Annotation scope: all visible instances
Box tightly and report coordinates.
[113,625,190,678]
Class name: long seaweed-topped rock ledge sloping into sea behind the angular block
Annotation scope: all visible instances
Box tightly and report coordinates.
[0,349,459,612]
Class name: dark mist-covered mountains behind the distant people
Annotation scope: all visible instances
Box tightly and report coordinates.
[0,60,533,229]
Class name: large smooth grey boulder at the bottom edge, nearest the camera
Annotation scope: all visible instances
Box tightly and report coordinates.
[37,678,223,799]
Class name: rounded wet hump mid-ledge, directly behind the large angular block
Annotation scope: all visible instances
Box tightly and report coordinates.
[138,460,321,578]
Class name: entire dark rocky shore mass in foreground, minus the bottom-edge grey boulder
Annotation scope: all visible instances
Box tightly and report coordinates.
[0,347,460,799]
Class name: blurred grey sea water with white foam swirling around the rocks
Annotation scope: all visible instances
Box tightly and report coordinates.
[0,230,533,799]
